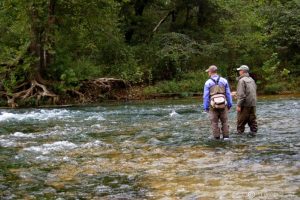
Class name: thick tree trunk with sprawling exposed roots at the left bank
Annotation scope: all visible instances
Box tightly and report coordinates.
[7,0,58,107]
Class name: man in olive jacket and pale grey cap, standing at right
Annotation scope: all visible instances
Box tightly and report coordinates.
[236,65,257,137]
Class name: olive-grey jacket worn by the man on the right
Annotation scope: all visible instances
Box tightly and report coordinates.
[236,73,257,107]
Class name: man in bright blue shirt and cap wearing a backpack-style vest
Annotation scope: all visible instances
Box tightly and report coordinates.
[203,65,232,140]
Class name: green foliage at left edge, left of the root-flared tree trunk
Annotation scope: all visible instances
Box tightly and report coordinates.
[0,1,34,94]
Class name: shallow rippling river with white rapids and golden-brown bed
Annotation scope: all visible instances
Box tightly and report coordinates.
[0,98,300,200]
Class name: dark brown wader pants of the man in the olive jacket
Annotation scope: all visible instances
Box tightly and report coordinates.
[237,106,257,133]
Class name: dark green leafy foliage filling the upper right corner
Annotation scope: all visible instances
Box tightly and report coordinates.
[265,0,300,76]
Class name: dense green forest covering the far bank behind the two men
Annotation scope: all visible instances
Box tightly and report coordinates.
[0,0,300,106]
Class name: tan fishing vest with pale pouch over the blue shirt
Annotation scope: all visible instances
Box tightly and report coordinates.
[209,76,227,109]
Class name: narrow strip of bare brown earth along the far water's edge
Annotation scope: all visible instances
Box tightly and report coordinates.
[0,87,300,109]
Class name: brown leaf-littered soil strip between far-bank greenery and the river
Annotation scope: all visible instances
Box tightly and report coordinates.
[0,83,300,109]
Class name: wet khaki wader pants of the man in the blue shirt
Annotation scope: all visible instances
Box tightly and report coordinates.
[209,108,229,138]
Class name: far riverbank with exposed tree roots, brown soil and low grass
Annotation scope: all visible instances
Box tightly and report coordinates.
[0,71,300,108]
